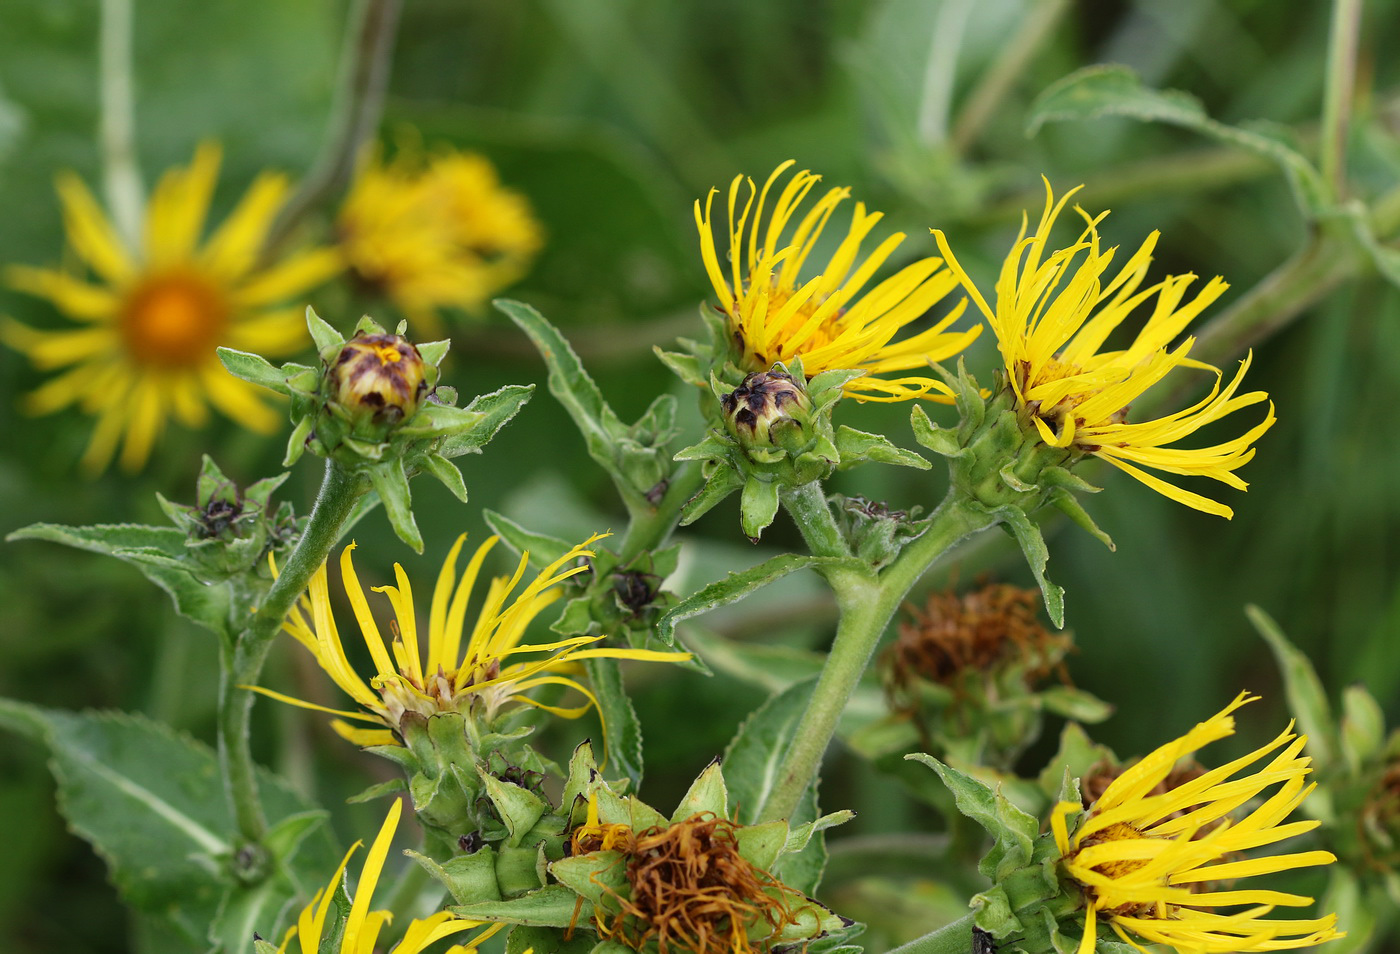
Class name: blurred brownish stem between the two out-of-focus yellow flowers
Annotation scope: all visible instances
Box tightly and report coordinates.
[265,0,402,254]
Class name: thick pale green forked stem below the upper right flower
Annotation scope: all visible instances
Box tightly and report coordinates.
[763,495,994,821]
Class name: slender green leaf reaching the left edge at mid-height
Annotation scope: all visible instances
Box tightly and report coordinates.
[6,524,230,635]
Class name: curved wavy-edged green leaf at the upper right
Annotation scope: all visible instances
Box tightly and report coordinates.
[1026,64,1331,217]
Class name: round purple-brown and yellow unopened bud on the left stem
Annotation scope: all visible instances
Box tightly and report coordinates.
[329,333,428,424]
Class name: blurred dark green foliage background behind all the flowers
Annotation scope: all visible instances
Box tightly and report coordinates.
[0,0,1400,954]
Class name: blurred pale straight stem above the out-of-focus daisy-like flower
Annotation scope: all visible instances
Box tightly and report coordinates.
[98,0,146,248]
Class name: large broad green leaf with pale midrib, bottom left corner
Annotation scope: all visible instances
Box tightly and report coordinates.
[0,699,340,954]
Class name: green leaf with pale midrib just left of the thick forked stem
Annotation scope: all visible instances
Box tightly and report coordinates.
[724,677,816,825]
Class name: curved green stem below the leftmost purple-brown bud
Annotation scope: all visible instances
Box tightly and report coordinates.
[218,461,367,845]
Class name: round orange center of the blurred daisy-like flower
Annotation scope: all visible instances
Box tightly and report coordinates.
[120,272,230,368]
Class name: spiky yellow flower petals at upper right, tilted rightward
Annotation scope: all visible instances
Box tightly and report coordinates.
[934,181,1274,518]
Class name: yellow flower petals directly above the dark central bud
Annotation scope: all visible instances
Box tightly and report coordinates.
[694,160,981,401]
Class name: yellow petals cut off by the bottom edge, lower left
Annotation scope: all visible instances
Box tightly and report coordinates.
[277,799,504,954]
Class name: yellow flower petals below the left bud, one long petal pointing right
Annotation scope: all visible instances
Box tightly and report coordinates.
[258,534,690,745]
